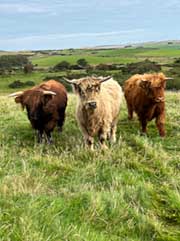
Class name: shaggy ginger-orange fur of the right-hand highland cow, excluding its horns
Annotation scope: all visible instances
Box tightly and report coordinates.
[124,73,166,137]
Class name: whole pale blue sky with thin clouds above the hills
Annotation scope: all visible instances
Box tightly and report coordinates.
[0,0,180,50]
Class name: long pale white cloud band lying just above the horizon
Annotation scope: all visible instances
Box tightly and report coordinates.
[0,29,144,50]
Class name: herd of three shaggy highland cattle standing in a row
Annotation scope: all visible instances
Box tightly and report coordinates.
[9,73,171,150]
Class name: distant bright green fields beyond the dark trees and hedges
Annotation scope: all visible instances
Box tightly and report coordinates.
[31,43,180,67]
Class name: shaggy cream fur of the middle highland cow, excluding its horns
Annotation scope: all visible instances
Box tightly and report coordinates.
[71,77,122,149]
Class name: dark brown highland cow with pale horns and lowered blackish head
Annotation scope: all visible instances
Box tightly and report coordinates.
[10,80,67,143]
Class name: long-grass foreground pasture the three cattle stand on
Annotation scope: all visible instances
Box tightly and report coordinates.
[0,92,180,241]
